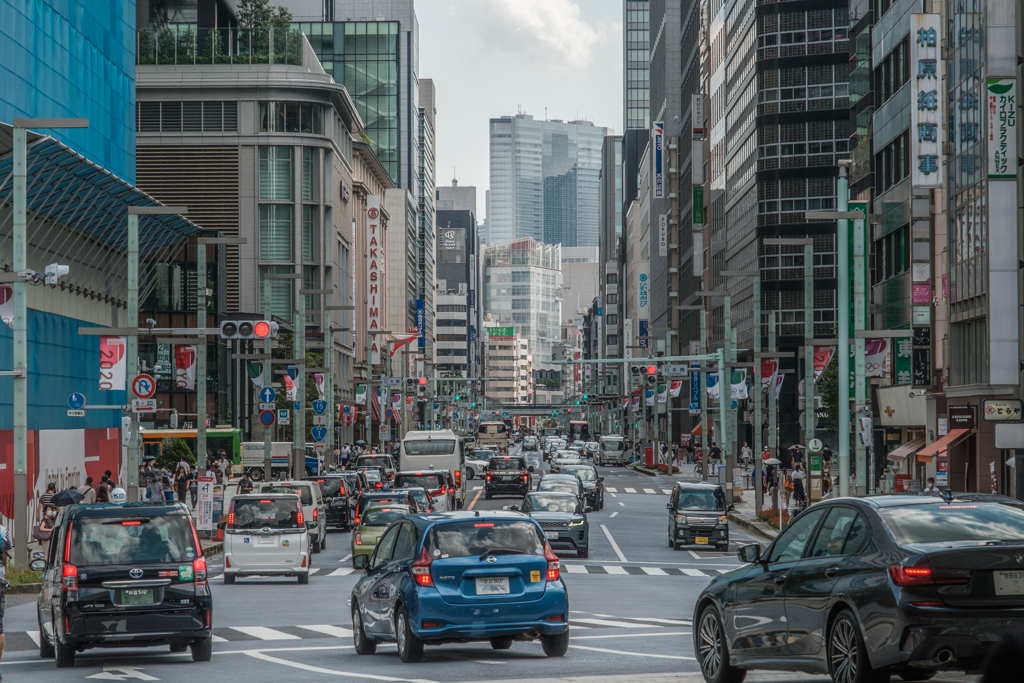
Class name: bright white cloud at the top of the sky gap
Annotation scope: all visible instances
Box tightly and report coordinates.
[472,0,604,69]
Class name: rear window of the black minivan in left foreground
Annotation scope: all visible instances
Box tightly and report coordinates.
[69,515,197,567]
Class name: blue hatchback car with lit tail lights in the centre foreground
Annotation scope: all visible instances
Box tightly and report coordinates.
[352,510,569,663]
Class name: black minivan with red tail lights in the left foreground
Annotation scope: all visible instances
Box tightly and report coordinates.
[37,503,213,668]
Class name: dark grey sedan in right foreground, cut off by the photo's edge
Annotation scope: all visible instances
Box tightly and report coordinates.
[693,493,1024,683]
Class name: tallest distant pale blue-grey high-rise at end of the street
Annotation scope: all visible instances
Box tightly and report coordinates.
[487,114,607,247]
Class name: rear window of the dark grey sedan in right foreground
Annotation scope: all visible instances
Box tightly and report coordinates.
[882,502,1024,543]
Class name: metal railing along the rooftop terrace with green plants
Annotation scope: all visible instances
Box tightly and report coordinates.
[135,25,306,67]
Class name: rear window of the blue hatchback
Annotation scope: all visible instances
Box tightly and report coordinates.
[425,517,545,559]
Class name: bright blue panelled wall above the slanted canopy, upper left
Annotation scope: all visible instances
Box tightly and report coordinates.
[0,0,135,184]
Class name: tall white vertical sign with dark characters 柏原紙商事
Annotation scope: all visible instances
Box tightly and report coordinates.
[910,14,945,187]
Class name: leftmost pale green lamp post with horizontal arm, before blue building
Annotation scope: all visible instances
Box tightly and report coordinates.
[11,119,87,567]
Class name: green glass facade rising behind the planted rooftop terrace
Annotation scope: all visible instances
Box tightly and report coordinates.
[293,22,404,182]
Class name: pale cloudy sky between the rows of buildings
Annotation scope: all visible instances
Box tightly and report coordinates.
[416,0,623,221]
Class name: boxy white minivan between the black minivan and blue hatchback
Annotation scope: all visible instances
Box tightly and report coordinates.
[218,493,312,584]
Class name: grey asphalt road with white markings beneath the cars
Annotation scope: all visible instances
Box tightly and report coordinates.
[2,446,983,683]
